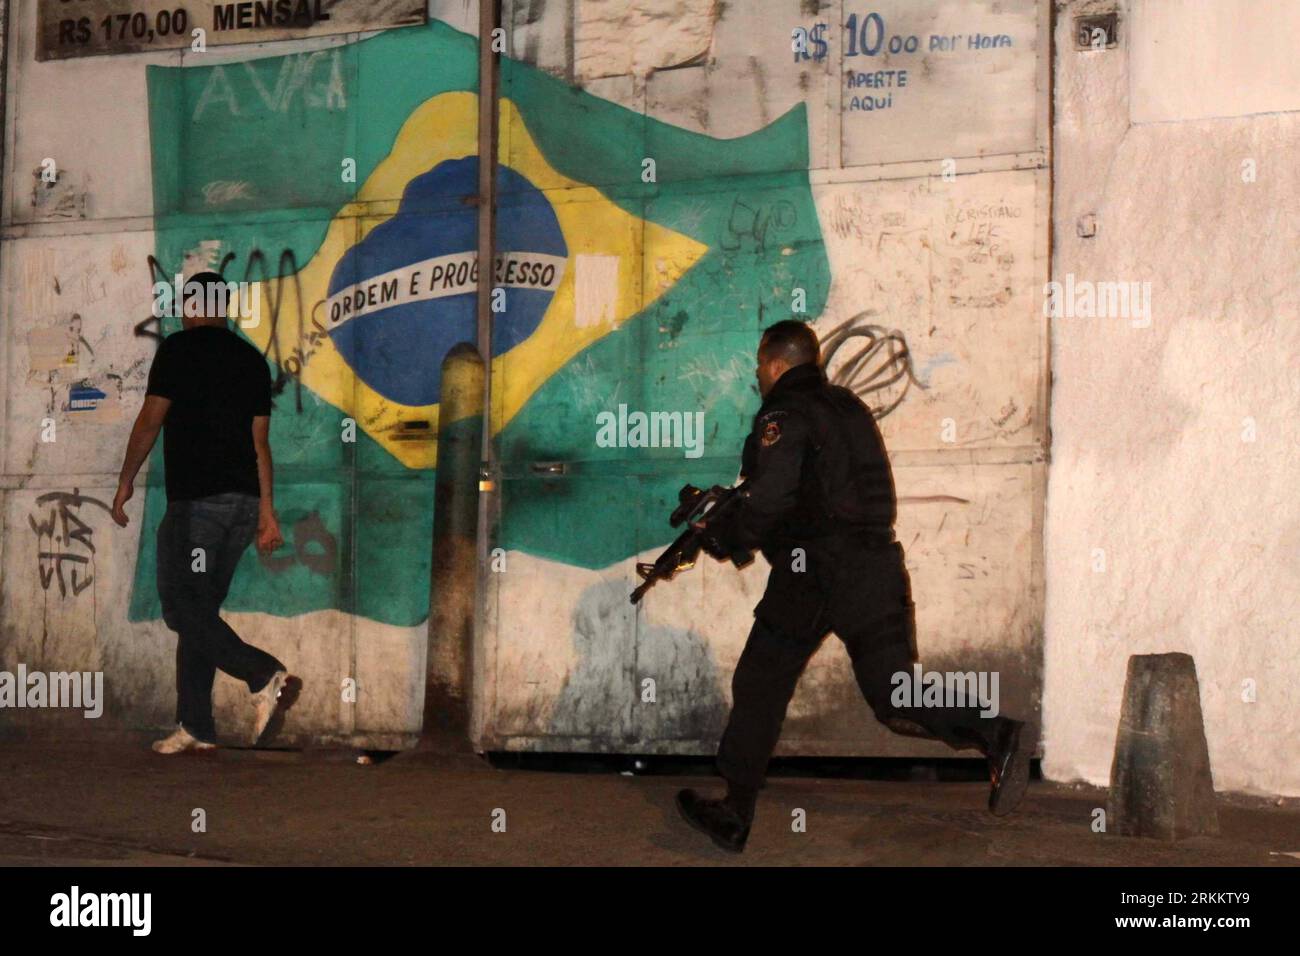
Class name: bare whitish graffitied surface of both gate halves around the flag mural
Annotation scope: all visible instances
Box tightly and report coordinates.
[0,0,1048,756]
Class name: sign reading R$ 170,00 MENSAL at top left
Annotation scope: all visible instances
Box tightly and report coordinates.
[36,0,426,60]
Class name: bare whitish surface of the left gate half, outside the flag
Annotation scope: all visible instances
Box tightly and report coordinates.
[0,0,462,749]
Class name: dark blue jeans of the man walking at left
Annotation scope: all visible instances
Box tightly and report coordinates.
[157,492,283,743]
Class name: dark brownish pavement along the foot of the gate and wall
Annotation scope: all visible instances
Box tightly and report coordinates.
[0,741,1300,866]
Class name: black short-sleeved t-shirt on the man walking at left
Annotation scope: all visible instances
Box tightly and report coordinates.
[146,325,270,501]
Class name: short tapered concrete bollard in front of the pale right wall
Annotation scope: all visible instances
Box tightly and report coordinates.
[1106,653,1218,840]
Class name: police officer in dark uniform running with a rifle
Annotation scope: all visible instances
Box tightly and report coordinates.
[677,321,1028,853]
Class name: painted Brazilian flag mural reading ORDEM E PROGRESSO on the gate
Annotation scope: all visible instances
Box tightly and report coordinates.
[131,21,829,626]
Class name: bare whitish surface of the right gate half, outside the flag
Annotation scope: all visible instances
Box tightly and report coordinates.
[480,0,1050,757]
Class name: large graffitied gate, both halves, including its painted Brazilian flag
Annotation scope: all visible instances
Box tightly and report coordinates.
[0,0,1049,754]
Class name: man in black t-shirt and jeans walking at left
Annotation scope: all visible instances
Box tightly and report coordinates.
[113,272,298,753]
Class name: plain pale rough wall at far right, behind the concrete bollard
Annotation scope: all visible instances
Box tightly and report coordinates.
[1044,0,1300,795]
